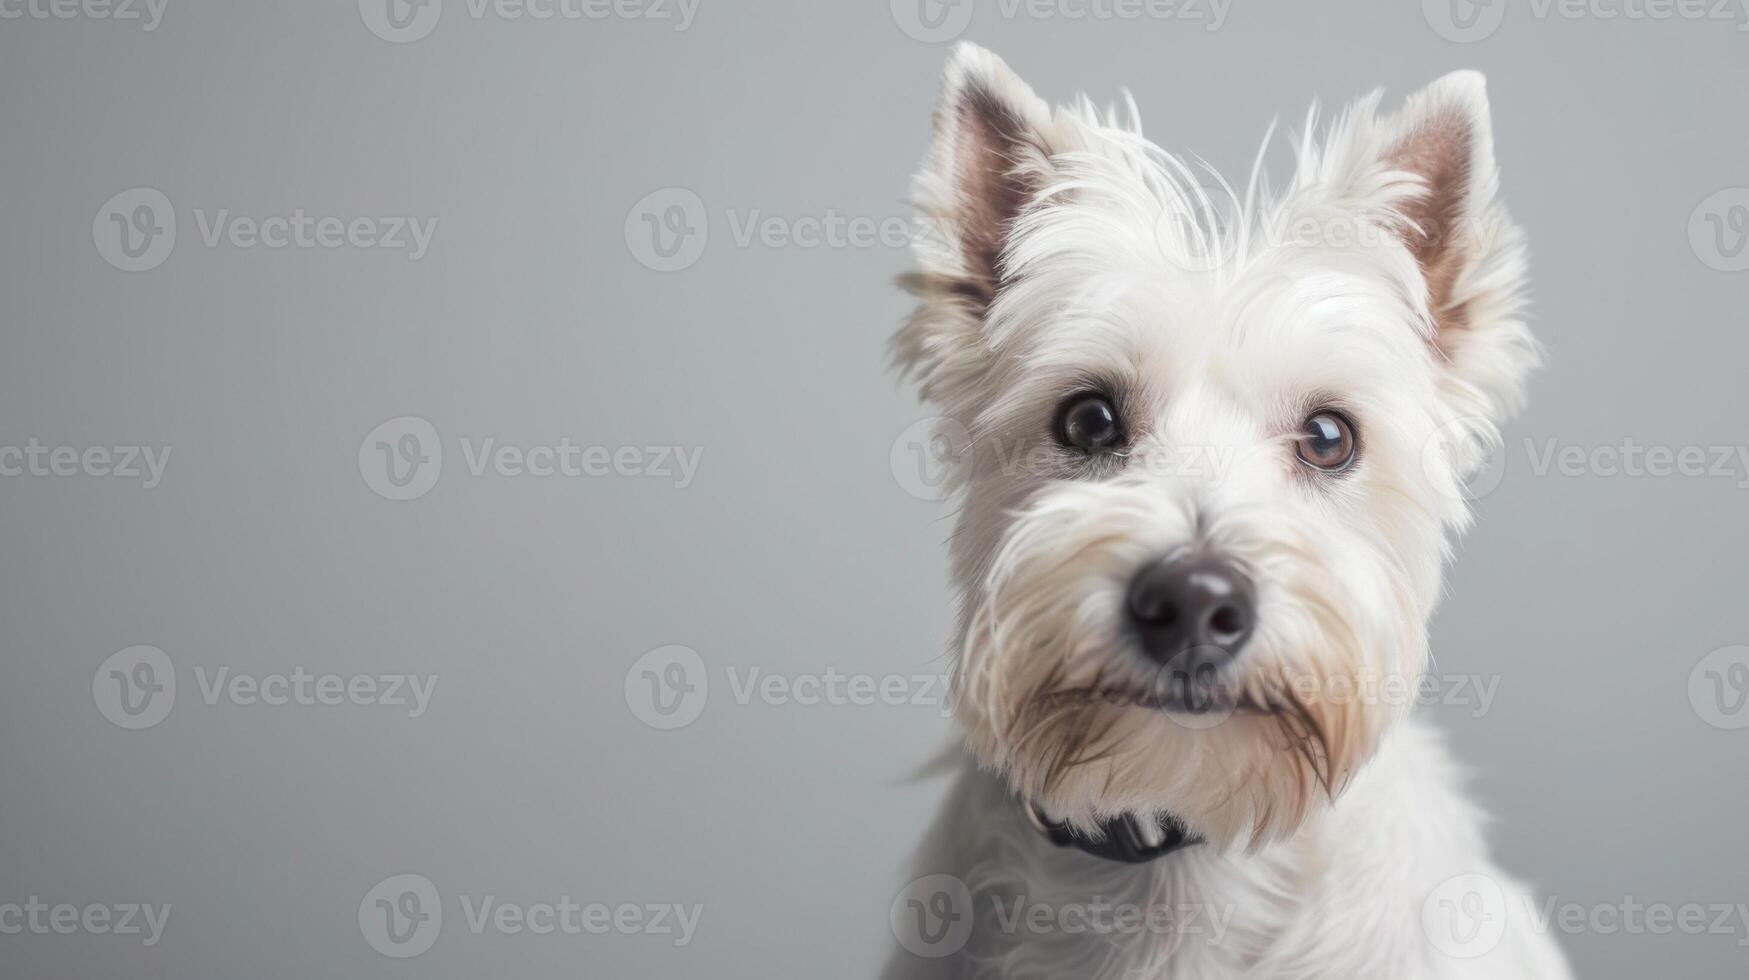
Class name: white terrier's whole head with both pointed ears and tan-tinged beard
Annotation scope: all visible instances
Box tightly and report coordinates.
[895,46,1536,847]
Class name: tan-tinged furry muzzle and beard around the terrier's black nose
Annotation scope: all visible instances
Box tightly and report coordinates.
[955,480,1422,847]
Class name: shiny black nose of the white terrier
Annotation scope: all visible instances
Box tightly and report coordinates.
[1128,555,1256,663]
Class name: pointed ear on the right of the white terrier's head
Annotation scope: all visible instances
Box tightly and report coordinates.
[1380,72,1539,422]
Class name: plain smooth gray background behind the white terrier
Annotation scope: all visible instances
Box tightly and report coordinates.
[0,0,1749,980]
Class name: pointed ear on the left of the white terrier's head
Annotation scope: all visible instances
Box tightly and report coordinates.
[913,44,1056,305]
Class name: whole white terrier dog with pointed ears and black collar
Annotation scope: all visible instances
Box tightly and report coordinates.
[887,46,1569,980]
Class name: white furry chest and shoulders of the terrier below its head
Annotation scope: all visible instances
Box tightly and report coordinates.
[885,723,1567,980]
